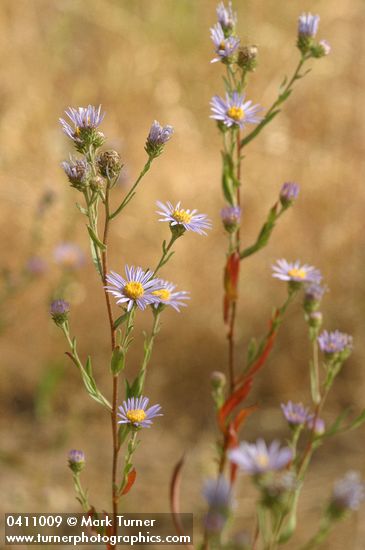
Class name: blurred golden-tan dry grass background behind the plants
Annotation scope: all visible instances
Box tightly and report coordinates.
[0,0,365,550]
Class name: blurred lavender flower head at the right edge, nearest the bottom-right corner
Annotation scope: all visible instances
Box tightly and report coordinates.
[331,471,365,513]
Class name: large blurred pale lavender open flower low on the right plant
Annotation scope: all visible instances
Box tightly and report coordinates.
[228,439,293,475]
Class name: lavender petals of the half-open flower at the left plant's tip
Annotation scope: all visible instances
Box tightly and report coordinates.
[59,105,105,142]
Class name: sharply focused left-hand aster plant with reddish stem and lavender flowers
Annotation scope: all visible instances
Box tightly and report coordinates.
[50,101,211,534]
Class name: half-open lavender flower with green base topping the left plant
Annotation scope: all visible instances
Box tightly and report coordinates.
[59,105,105,149]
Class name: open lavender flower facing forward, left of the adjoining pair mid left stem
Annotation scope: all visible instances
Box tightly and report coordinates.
[105,265,159,311]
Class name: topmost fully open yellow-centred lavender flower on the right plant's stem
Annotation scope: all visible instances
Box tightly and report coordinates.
[210,92,262,128]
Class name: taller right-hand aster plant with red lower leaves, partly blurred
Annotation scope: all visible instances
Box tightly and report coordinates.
[166,2,365,550]
